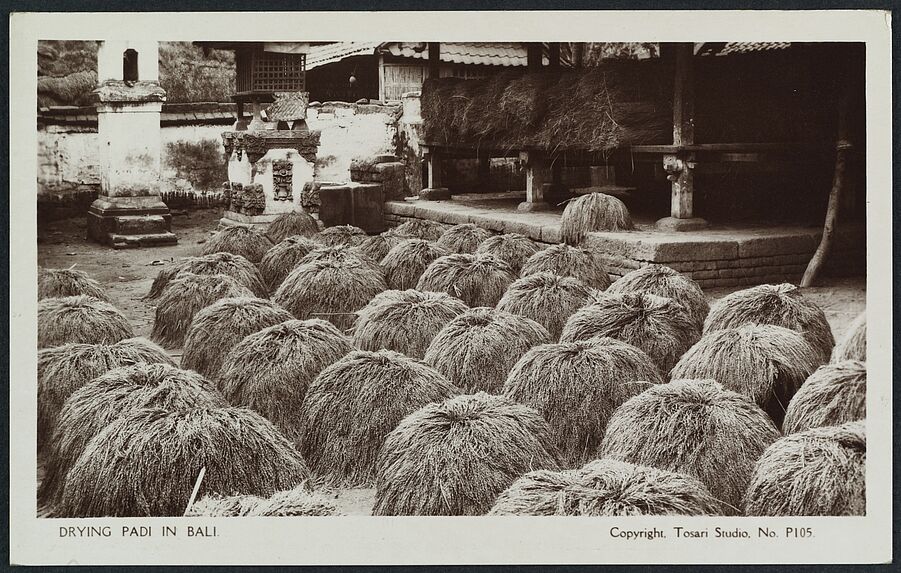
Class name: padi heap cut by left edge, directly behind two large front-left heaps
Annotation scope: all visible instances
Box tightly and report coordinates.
[38,338,175,452]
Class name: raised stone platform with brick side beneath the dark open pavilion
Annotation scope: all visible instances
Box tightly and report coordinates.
[385,201,866,288]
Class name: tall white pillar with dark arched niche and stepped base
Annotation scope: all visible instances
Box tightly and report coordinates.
[87,40,178,248]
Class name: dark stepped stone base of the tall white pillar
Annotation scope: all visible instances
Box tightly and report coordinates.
[87,195,178,249]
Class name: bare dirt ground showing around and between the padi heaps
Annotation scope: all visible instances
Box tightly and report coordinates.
[38,209,866,515]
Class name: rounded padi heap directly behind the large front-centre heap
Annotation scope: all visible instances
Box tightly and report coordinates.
[424,307,551,393]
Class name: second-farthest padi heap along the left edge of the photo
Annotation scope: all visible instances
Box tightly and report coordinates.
[38,295,134,348]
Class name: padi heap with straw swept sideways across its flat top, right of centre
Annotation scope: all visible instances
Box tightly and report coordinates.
[560,292,701,373]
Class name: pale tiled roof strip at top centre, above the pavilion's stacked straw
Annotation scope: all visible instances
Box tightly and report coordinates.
[380,42,547,66]
